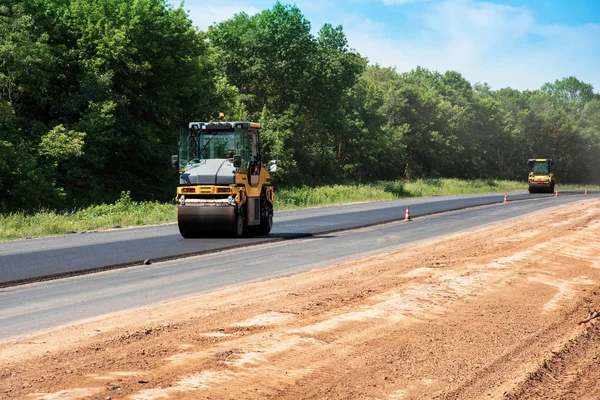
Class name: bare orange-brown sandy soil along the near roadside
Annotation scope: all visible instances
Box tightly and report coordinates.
[0,200,600,400]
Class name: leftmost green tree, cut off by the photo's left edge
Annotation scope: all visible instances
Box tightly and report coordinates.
[0,1,58,211]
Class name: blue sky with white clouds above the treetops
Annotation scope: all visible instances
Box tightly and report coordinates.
[170,0,600,92]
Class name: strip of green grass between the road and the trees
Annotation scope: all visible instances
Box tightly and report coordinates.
[0,179,600,241]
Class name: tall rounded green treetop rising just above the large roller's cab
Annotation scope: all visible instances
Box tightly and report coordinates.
[208,3,316,118]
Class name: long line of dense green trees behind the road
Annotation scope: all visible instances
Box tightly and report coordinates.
[0,0,600,212]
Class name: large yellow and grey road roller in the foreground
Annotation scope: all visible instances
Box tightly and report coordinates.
[171,121,277,238]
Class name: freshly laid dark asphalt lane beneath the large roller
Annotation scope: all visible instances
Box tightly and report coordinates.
[0,191,583,287]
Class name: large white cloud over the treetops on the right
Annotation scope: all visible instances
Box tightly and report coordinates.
[344,0,600,91]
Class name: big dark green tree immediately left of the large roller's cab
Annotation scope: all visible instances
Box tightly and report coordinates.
[56,0,233,199]
